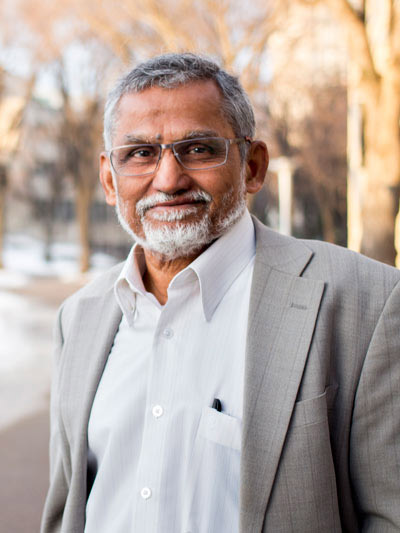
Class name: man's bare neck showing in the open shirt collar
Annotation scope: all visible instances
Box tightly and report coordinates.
[143,246,204,305]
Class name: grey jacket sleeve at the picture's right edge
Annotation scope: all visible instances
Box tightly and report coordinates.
[349,276,400,533]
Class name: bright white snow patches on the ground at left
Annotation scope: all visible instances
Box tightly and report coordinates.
[0,235,116,430]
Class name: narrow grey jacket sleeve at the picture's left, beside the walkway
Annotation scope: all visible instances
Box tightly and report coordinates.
[40,308,69,533]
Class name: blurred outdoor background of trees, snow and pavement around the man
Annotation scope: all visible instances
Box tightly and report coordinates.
[0,0,400,533]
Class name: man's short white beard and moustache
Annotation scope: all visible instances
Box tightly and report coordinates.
[116,180,246,261]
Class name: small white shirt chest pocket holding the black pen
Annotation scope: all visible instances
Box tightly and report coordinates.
[198,407,242,451]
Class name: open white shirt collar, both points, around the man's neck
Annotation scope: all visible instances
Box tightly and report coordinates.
[114,209,256,324]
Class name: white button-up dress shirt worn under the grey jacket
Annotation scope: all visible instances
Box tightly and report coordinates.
[85,211,255,533]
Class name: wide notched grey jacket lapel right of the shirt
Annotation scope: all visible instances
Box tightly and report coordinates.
[240,223,324,533]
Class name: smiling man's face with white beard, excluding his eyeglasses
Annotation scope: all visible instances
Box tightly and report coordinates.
[101,81,260,259]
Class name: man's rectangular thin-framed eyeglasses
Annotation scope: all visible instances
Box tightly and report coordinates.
[107,137,251,176]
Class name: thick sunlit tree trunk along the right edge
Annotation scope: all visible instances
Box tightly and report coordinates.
[301,0,400,264]
